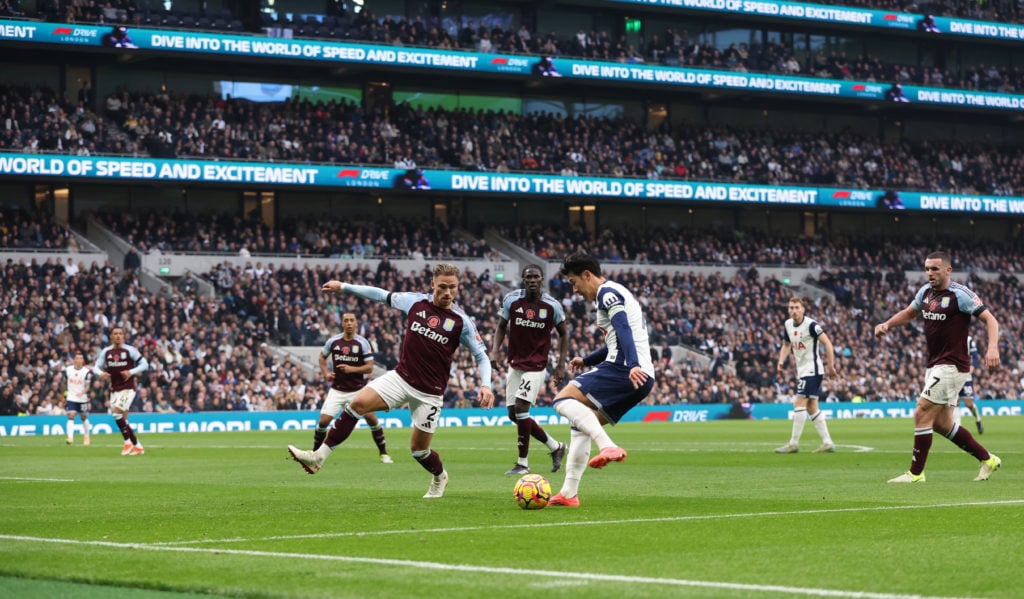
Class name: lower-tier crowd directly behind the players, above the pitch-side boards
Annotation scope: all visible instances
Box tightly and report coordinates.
[0,212,1024,414]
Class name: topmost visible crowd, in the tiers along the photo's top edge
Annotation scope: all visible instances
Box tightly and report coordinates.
[24,0,1024,93]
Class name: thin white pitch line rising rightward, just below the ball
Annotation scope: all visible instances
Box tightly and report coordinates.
[150,499,1024,547]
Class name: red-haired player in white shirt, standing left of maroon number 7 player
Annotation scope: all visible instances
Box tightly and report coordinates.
[775,297,839,454]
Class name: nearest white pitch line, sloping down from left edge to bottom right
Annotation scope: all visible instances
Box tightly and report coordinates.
[0,534,974,599]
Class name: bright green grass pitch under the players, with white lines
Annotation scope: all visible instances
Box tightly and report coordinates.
[0,417,1024,599]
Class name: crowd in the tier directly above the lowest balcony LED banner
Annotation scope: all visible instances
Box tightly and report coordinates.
[6,85,1024,196]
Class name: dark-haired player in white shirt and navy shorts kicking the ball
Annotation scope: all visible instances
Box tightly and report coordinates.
[548,254,654,507]
